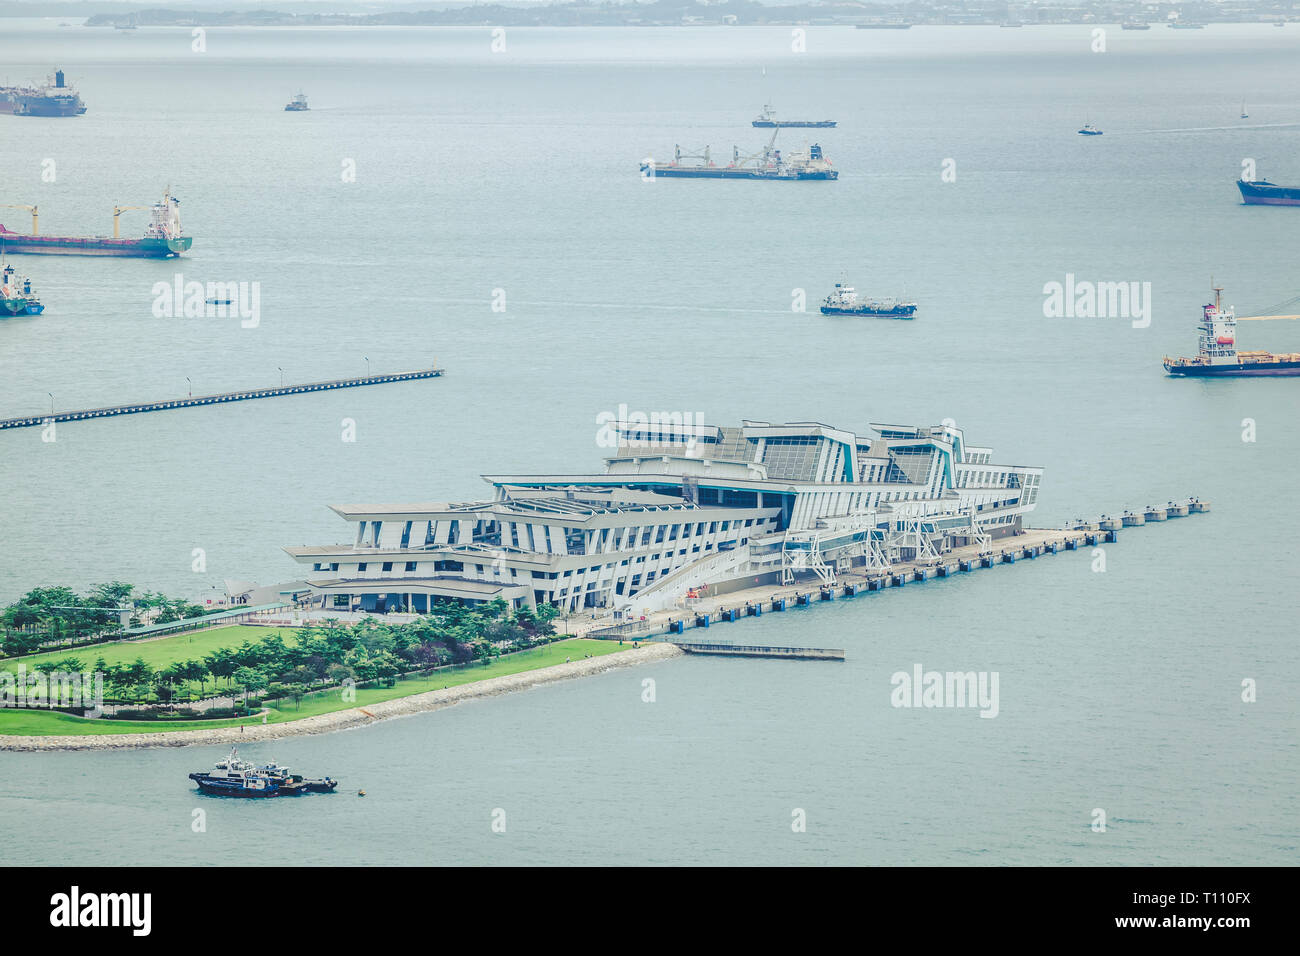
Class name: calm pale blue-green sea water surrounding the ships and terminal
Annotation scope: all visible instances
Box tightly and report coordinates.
[0,21,1300,865]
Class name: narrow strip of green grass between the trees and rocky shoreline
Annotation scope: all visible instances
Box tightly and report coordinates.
[0,639,632,736]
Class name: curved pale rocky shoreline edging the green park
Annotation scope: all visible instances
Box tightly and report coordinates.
[0,644,683,750]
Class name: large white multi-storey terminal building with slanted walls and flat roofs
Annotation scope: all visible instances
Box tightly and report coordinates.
[285,421,1043,617]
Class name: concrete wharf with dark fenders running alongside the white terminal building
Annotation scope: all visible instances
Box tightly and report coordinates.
[585,499,1210,642]
